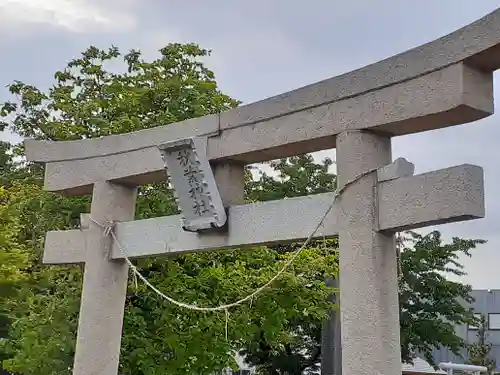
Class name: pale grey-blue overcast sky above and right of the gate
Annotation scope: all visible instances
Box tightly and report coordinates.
[0,0,500,289]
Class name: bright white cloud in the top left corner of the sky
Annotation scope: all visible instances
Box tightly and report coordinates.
[0,0,136,32]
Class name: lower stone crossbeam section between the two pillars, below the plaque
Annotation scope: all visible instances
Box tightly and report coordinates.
[112,190,338,258]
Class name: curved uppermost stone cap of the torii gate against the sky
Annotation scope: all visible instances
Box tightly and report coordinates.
[26,9,500,162]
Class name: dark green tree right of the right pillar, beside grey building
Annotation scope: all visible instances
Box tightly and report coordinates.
[399,231,485,365]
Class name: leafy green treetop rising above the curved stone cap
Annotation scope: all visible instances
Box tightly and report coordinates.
[0,44,238,141]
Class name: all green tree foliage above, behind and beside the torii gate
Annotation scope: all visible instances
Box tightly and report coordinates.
[0,44,479,375]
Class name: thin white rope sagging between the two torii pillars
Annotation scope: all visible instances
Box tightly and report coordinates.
[89,168,377,314]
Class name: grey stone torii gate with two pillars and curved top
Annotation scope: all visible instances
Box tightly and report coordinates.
[26,9,500,375]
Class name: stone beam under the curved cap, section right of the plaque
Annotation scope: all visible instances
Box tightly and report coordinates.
[209,63,493,163]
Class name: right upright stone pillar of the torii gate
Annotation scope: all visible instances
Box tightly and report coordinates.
[337,130,401,375]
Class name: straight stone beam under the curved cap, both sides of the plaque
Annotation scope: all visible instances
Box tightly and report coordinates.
[37,63,493,194]
